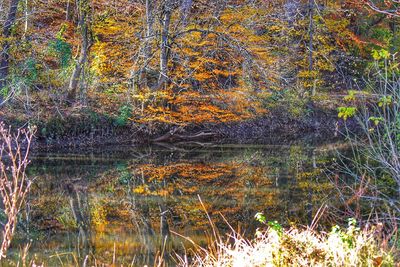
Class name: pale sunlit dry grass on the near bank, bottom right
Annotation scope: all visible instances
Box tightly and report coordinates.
[178,227,396,267]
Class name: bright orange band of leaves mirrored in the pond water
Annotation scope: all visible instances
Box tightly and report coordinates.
[126,159,271,200]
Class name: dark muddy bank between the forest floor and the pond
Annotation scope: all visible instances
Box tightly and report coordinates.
[4,107,355,150]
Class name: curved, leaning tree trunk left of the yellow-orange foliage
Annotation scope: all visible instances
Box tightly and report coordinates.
[67,0,91,103]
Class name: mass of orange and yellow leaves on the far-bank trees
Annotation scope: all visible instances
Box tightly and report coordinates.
[87,0,272,125]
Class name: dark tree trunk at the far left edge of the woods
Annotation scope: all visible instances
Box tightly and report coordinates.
[0,0,19,105]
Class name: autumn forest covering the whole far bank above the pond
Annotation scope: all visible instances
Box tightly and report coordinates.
[0,0,399,146]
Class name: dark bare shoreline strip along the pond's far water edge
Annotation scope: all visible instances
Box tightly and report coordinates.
[25,110,357,150]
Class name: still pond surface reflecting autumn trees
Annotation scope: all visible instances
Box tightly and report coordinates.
[7,144,344,266]
